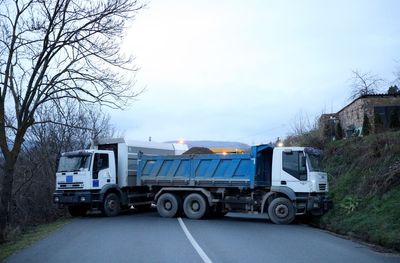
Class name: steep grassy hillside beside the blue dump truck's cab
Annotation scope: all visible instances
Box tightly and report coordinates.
[317,132,400,250]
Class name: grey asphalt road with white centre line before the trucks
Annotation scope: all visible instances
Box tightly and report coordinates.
[5,211,400,263]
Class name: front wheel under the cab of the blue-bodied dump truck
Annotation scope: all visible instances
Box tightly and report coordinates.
[268,197,296,224]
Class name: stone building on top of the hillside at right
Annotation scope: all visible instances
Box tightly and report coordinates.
[319,94,400,137]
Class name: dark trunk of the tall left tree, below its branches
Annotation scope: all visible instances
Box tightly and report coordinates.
[0,156,17,241]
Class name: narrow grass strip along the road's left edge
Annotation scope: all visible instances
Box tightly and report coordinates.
[0,219,69,262]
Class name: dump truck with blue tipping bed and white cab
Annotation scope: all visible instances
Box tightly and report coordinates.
[137,145,330,224]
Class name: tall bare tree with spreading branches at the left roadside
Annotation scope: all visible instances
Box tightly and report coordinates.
[0,0,143,240]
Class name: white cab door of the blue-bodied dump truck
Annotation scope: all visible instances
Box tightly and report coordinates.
[281,151,310,192]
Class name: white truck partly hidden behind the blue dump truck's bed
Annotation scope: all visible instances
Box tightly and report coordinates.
[53,138,188,216]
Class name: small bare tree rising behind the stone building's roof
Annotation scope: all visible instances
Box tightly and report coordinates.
[350,70,383,99]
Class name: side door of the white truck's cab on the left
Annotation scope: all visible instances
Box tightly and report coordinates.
[92,153,115,189]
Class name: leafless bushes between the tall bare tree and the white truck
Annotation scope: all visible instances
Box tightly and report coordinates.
[0,103,118,244]
